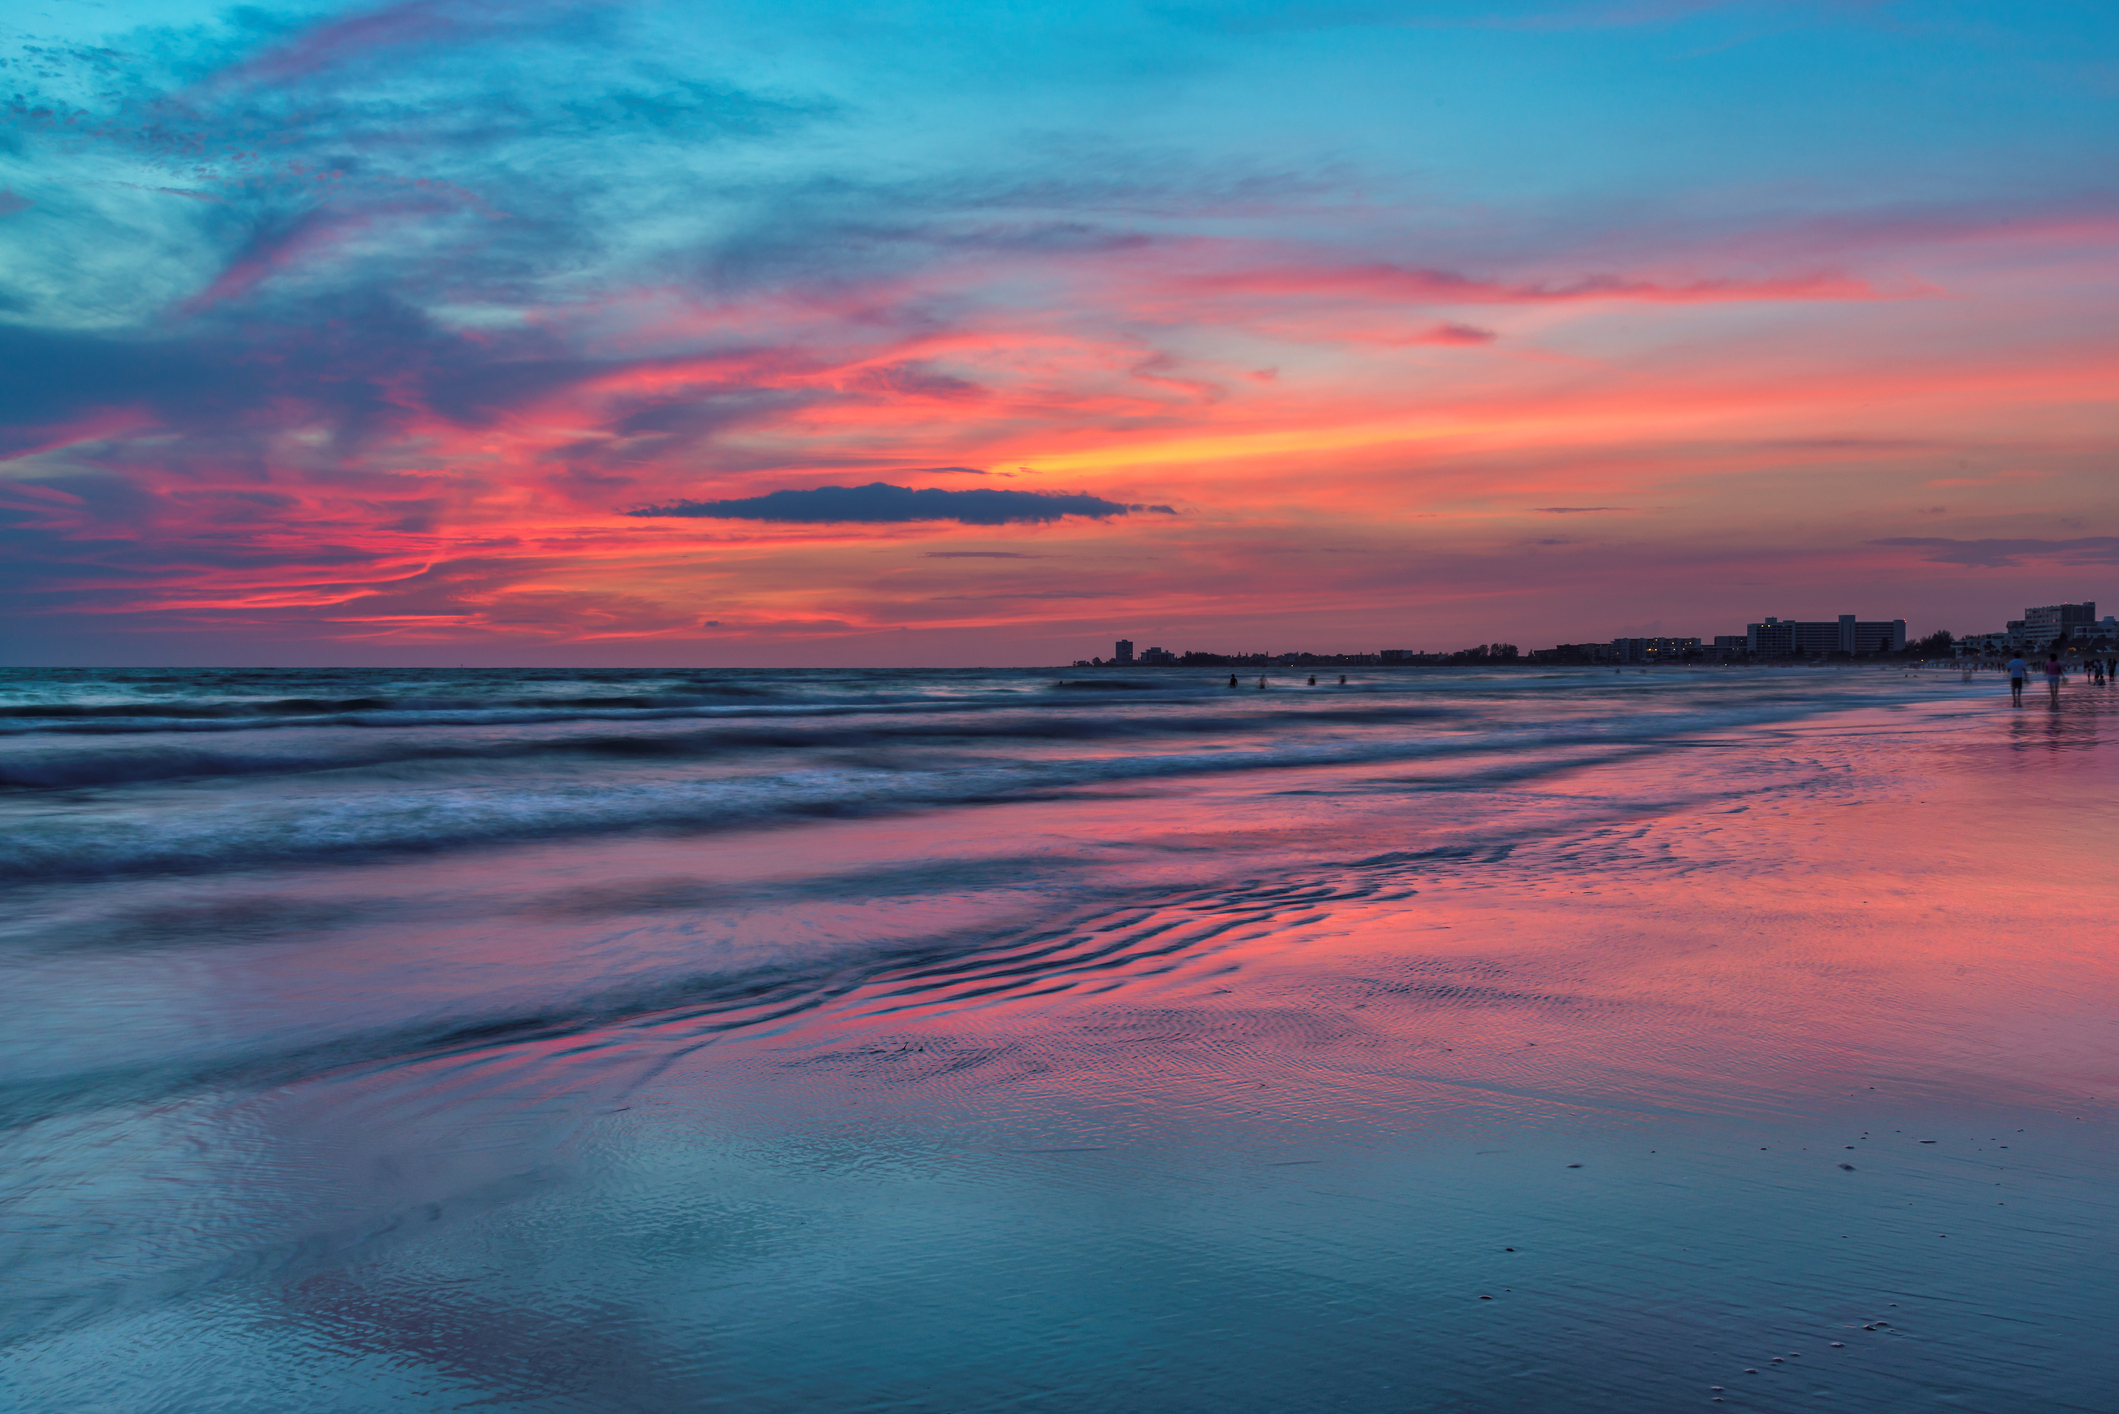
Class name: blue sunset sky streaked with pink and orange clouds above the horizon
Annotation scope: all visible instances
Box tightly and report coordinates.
[0,0,2119,666]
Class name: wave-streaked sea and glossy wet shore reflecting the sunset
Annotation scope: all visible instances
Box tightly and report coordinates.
[0,670,2119,1412]
